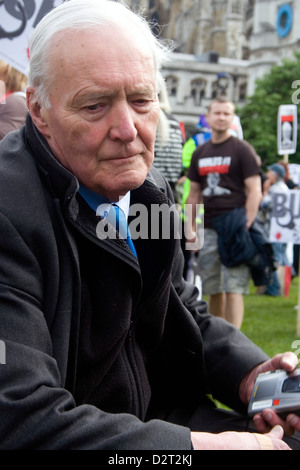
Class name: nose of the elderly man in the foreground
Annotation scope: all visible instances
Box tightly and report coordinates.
[109,103,137,142]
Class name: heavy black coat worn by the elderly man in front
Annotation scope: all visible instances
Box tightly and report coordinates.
[0,118,266,449]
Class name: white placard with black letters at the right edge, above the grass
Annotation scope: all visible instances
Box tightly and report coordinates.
[270,189,300,244]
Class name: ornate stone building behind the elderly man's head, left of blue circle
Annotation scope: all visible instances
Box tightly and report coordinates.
[116,0,254,129]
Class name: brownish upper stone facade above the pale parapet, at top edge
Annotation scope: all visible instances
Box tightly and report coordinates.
[121,0,249,59]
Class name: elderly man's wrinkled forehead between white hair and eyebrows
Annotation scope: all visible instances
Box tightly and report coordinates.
[44,25,157,102]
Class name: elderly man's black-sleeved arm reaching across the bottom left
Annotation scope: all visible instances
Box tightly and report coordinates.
[0,212,190,450]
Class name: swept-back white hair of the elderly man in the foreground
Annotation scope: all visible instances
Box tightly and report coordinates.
[28,0,171,106]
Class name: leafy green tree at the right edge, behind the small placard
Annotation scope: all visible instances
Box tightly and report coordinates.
[238,52,300,169]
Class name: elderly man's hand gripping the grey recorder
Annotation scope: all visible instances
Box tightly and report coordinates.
[239,352,300,436]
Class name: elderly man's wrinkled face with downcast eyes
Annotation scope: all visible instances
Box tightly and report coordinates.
[28,29,159,200]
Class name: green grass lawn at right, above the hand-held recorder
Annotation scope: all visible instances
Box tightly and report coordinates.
[241,277,300,359]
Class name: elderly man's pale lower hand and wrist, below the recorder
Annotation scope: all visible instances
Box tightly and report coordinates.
[191,426,291,450]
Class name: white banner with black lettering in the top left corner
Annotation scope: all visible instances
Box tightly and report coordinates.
[0,0,64,75]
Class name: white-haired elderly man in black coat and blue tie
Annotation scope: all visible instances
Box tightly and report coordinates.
[0,0,300,450]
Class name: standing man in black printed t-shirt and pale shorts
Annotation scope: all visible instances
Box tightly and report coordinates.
[187,98,261,328]
